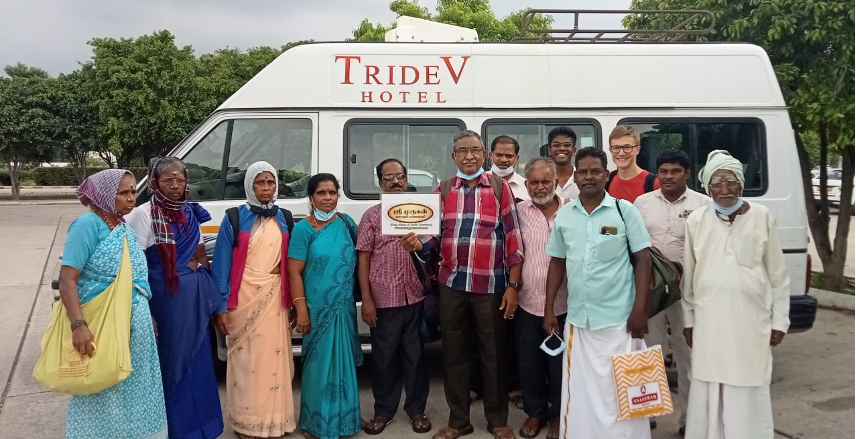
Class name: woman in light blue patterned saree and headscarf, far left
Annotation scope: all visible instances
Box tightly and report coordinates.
[59,169,167,439]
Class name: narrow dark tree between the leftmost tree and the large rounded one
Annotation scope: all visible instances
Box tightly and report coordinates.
[51,63,100,183]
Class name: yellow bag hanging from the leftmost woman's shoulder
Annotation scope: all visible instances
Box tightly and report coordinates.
[33,238,134,395]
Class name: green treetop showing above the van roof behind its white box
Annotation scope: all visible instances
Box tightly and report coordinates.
[352,0,553,41]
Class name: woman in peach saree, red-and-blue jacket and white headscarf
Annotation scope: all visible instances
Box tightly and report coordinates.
[213,162,296,439]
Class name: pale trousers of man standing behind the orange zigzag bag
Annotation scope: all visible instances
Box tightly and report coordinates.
[645,302,692,425]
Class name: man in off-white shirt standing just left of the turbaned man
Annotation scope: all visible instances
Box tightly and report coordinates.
[633,150,711,435]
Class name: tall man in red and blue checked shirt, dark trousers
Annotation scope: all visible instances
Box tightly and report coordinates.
[402,130,523,439]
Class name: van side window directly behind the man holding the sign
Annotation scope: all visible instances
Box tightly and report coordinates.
[345,119,464,199]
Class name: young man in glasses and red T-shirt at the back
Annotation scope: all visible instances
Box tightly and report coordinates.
[606,125,660,203]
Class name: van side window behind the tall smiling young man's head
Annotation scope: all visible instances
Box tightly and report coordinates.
[482,119,600,175]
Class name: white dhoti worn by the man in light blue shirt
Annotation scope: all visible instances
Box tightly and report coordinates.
[559,324,651,439]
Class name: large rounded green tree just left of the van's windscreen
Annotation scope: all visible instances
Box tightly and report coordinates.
[89,31,201,167]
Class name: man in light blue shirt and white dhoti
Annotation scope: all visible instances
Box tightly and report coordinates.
[544,147,651,439]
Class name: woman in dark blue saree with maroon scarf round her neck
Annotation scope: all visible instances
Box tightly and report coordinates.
[127,157,223,439]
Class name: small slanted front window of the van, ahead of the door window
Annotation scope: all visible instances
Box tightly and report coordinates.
[183,121,229,201]
